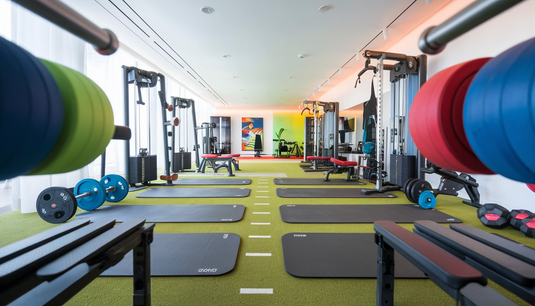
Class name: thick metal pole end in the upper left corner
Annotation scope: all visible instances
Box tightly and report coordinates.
[13,0,119,55]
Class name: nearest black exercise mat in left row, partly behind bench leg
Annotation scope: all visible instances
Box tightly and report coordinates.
[101,233,240,276]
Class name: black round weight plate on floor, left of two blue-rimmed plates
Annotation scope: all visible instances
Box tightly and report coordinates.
[36,187,78,223]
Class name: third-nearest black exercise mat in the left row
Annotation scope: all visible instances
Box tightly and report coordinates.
[136,187,251,198]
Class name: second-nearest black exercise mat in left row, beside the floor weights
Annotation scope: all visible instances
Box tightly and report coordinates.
[76,204,245,223]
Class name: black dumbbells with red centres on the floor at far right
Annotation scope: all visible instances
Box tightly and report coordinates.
[477,204,535,238]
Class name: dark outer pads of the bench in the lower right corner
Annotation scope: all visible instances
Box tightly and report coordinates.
[414,221,535,305]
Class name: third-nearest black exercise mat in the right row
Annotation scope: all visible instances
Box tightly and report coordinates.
[277,188,397,198]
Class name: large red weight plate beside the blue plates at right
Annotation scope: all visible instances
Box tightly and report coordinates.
[409,58,493,174]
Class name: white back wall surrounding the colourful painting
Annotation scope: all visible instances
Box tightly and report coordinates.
[212,109,273,156]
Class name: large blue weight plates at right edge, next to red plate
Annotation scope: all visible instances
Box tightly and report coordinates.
[464,39,535,183]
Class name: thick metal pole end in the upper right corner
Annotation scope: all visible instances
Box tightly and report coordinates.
[418,0,523,54]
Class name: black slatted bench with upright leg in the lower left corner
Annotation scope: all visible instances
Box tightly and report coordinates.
[0,219,154,305]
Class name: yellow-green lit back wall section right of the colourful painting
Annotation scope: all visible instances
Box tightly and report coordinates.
[273,111,305,154]
